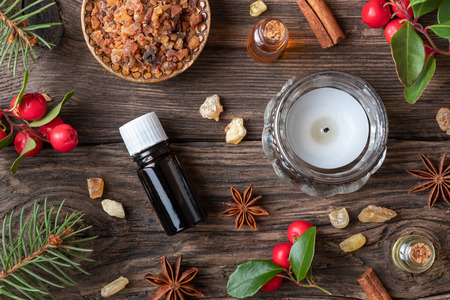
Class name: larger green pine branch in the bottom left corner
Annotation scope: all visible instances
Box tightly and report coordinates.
[0,199,96,300]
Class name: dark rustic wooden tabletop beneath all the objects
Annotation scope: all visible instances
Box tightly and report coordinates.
[0,0,450,300]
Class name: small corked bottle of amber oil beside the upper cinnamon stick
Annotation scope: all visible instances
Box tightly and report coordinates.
[247,18,289,63]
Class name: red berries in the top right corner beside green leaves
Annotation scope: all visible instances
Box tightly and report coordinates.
[361,0,433,57]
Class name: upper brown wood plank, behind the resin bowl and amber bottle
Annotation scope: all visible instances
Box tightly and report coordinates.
[0,0,450,144]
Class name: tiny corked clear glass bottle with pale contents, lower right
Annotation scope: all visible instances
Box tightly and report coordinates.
[392,235,435,273]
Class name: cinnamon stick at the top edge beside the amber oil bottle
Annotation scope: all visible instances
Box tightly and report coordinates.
[296,0,345,48]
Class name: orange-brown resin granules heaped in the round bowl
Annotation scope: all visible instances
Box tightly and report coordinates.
[90,0,203,76]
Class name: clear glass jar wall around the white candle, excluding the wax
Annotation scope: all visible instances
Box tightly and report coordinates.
[262,71,388,197]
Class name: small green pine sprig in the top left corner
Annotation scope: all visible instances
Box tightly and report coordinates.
[0,0,61,77]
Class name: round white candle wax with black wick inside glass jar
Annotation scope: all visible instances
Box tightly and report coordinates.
[286,88,369,169]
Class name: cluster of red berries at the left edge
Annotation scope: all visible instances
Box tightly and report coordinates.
[0,93,78,156]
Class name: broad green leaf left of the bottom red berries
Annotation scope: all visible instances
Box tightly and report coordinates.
[227,260,284,299]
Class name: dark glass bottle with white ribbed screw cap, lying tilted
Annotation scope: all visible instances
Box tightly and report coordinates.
[120,112,206,235]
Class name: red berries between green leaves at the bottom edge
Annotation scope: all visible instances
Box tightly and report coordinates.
[261,221,312,292]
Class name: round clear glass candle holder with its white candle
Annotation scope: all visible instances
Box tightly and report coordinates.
[262,71,388,197]
